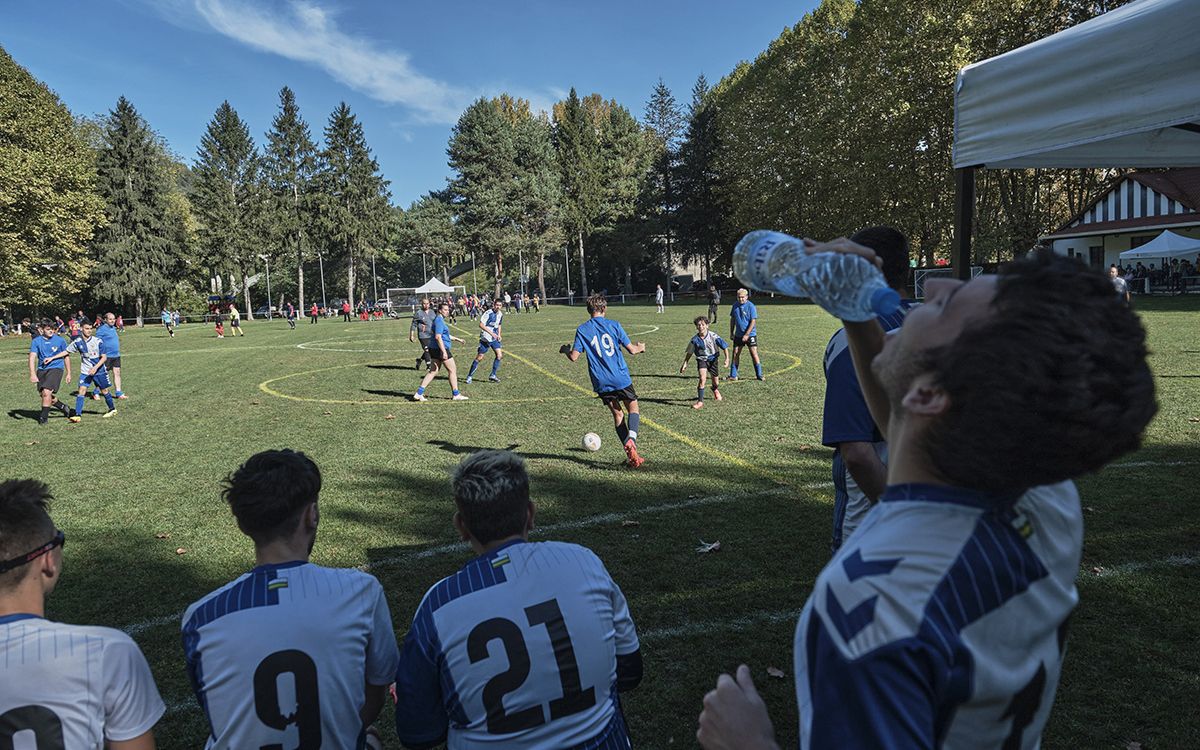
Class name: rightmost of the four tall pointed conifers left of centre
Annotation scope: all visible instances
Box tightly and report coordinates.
[316,102,391,304]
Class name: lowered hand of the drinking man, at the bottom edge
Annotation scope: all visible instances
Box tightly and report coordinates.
[696,664,779,750]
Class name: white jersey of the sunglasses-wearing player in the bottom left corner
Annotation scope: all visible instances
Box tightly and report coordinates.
[0,614,166,750]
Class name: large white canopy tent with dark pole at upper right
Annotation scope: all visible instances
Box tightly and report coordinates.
[954,0,1200,275]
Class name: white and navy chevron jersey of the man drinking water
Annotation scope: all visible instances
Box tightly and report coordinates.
[794,481,1084,750]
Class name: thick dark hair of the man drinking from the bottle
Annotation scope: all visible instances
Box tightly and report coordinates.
[923,251,1158,494]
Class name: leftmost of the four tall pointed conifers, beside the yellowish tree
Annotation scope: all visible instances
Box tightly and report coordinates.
[92,96,186,325]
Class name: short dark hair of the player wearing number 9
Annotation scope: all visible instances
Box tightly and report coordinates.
[221,448,320,544]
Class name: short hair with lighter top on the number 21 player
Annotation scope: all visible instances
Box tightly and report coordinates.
[450,450,529,545]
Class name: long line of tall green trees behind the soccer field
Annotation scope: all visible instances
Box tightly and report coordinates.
[0,0,1122,316]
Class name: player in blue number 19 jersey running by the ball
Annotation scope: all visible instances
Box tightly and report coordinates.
[559,294,646,469]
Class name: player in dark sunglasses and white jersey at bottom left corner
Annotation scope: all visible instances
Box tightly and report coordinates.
[0,479,166,750]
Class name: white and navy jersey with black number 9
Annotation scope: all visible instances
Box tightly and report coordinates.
[184,560,400,750]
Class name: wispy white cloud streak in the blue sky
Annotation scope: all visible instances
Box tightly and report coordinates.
[196,0,474,124]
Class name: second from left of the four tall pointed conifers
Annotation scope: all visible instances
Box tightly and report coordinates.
[193,102,264,317]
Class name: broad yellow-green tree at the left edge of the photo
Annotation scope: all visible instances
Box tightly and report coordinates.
[0,48,104,308]
